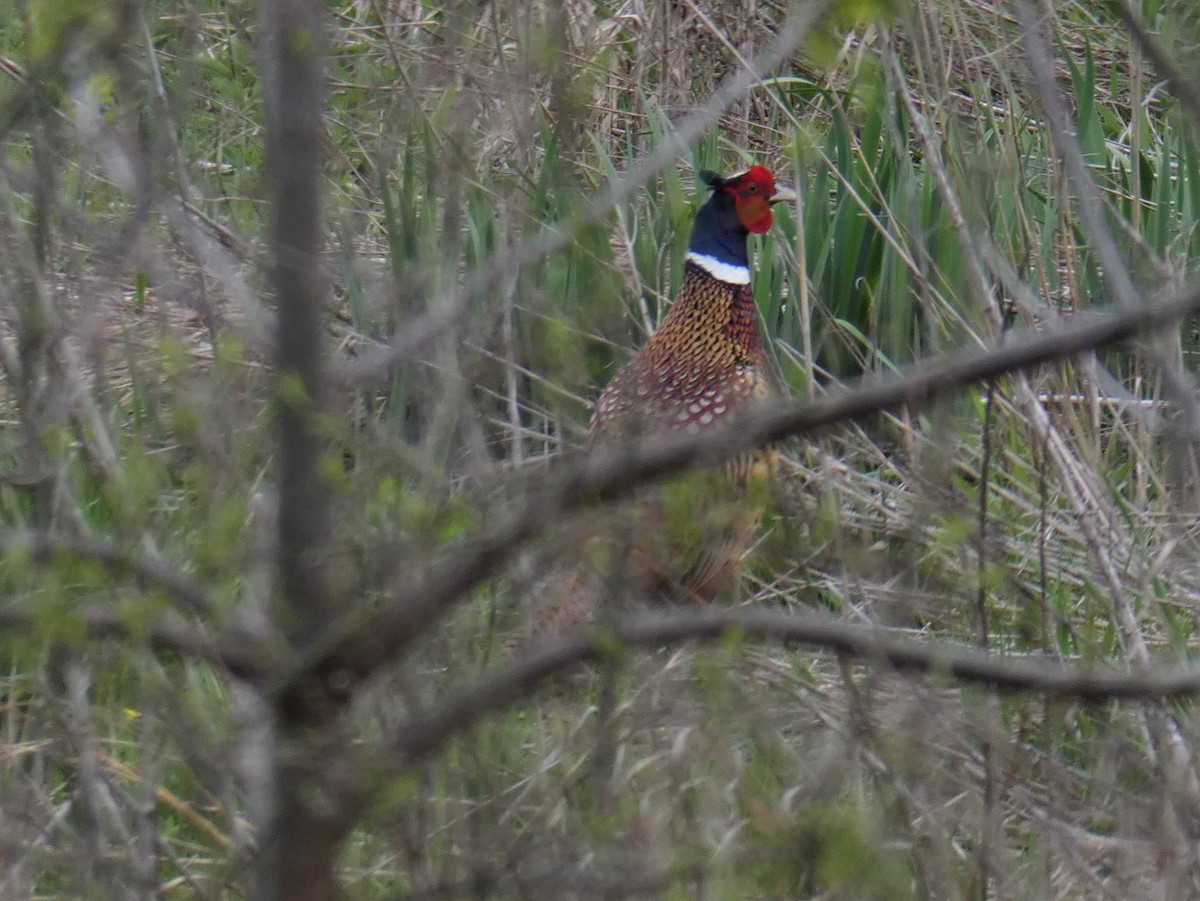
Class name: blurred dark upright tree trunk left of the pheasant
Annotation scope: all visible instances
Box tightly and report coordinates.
[258,0,349,901]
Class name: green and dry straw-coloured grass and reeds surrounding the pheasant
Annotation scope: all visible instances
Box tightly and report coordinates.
[0,0,1200,899]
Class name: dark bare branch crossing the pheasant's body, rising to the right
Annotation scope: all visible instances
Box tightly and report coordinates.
[281,274,1200,692]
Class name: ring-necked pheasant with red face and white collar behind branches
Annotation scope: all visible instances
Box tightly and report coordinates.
[505,166,794,651]
